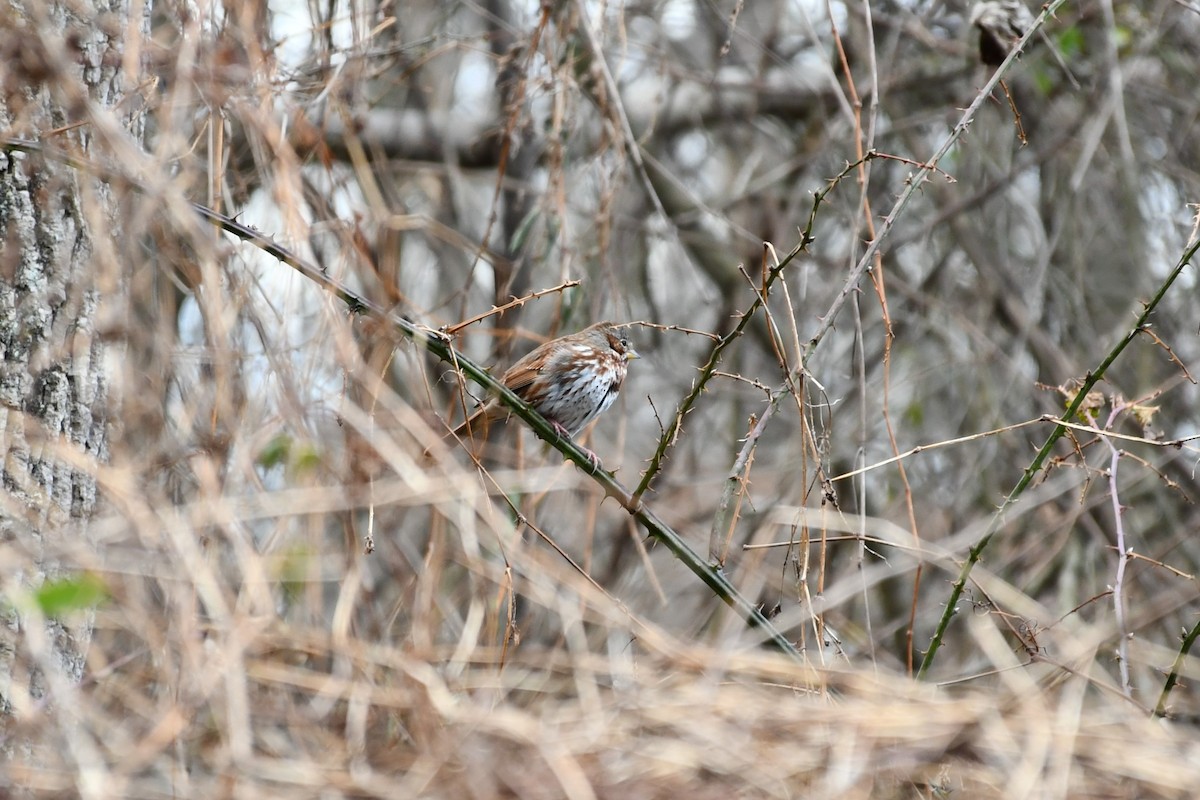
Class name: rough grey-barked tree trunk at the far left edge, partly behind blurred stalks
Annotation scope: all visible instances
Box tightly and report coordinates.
[0,0,138,724]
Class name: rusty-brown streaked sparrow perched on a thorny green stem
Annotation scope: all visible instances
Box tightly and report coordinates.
[454,323,638,462]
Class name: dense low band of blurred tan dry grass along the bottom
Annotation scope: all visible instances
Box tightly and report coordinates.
[5,548,1200,798]
